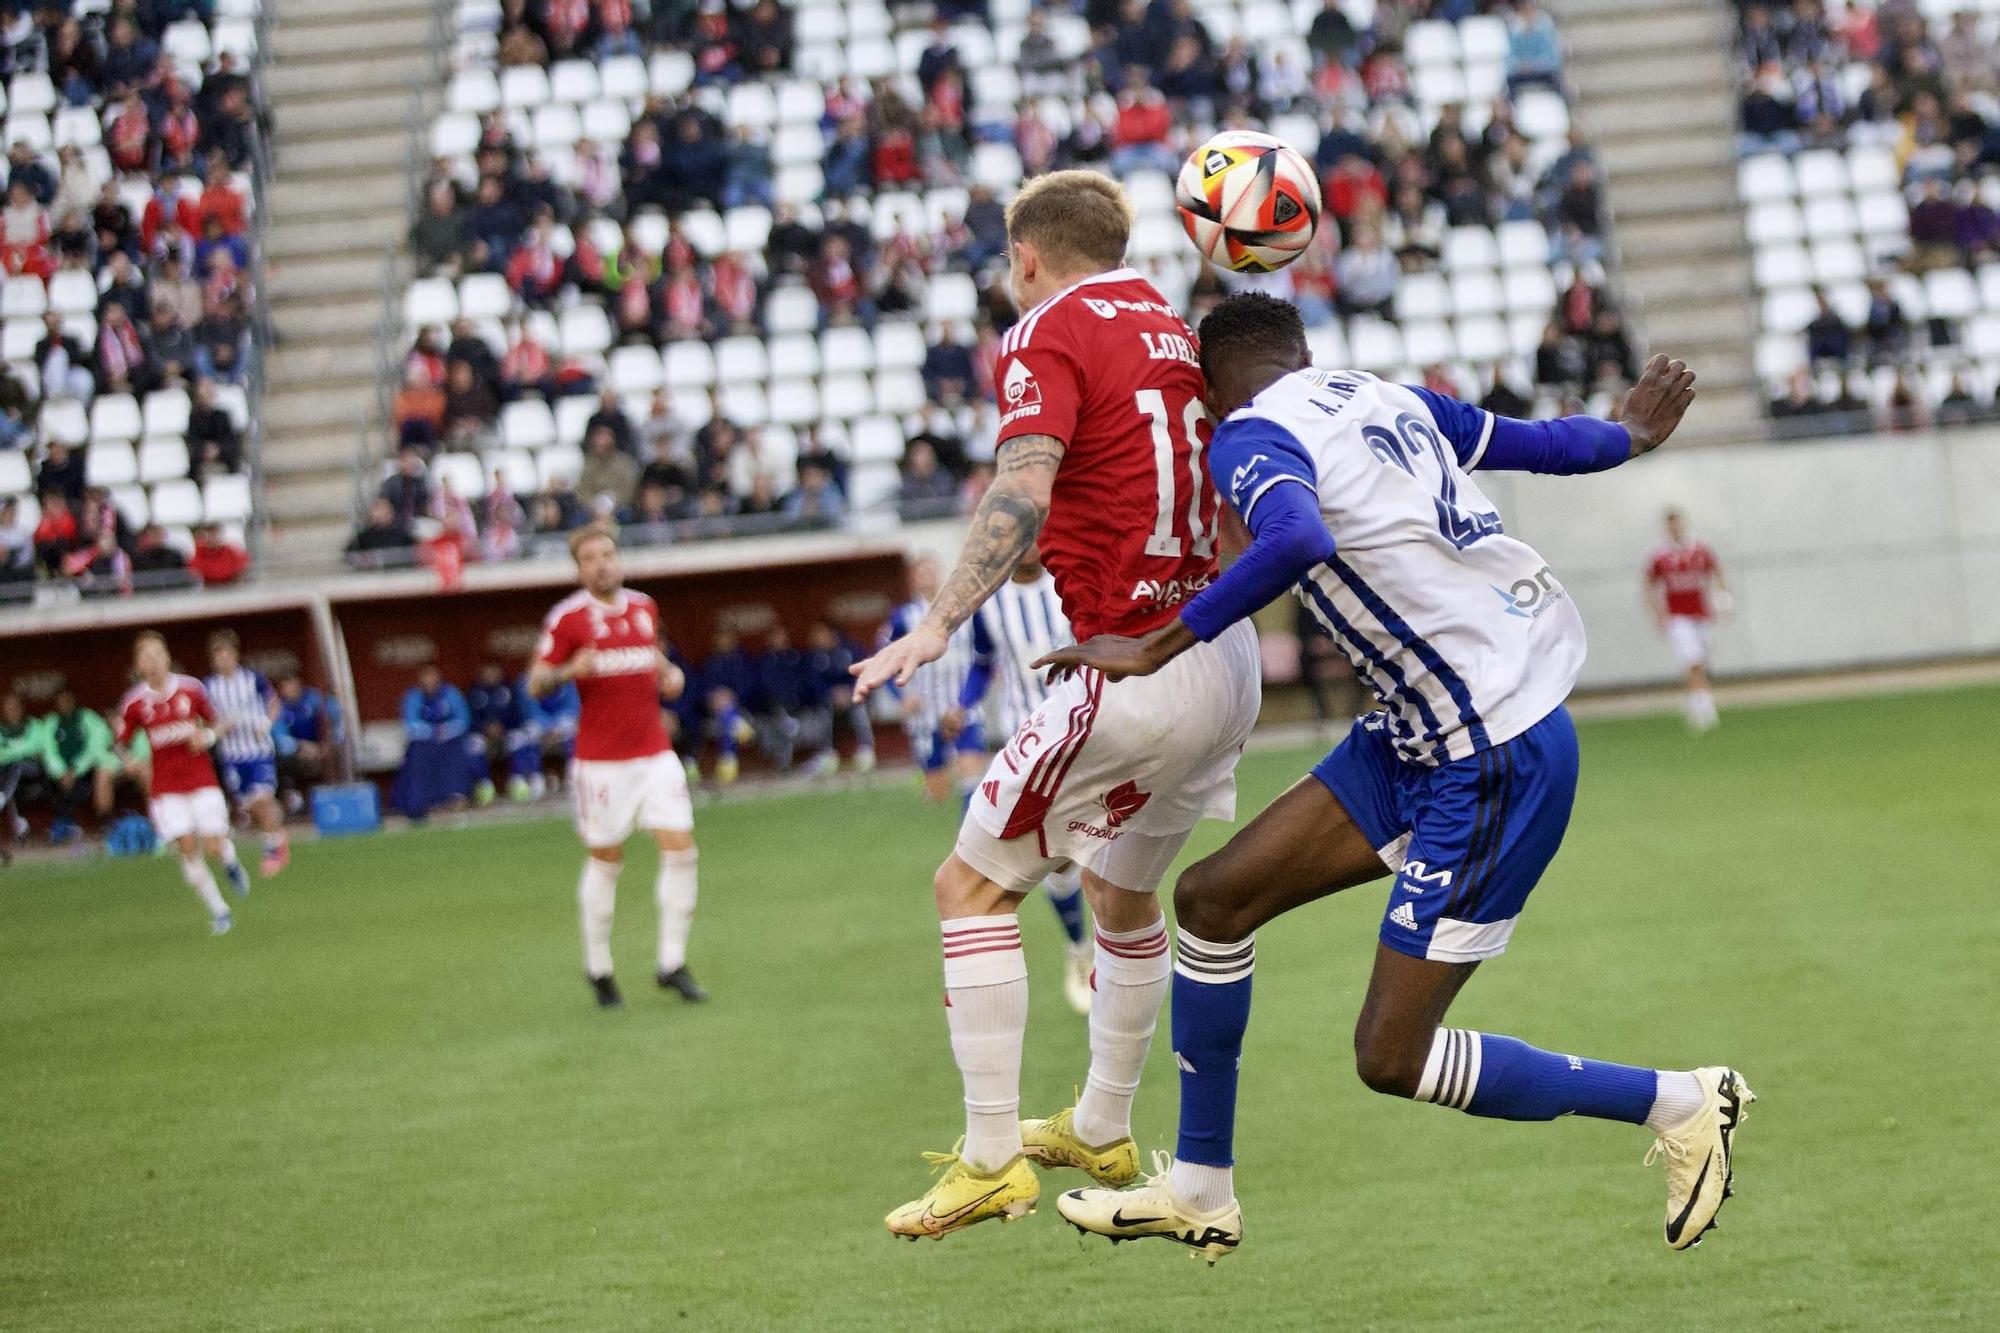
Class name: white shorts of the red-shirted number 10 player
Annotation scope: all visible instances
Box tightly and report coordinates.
[958,620,1262,893]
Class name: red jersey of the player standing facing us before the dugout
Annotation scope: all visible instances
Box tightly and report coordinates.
[534,588,670,759]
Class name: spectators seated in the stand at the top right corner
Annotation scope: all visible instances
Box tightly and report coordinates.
[1738,0,2000,434]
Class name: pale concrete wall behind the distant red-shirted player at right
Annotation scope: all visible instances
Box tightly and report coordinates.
[1480,428,2000,689]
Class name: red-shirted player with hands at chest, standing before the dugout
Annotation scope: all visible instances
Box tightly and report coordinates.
[528,524,708,1009]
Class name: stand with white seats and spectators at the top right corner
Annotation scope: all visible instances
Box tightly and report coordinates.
[1738,4,2000,434]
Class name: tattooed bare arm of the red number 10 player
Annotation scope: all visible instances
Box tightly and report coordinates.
[852,434,1064,701]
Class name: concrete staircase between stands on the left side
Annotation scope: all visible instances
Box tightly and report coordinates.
[262,0,444,566]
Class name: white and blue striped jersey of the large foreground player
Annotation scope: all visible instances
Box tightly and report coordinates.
[1216,368,1584,765]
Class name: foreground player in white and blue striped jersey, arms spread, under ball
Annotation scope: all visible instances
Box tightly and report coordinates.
[1046,294,1756,1263]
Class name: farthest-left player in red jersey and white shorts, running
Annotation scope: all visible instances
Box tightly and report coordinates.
[116,630,250,935]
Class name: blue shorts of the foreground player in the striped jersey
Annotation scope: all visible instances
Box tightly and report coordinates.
[1312,707,1576,963]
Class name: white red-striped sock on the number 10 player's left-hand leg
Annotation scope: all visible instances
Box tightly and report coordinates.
[942,913,1028,1171]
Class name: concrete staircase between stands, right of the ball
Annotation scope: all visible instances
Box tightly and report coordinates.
[1550,0,1766,440]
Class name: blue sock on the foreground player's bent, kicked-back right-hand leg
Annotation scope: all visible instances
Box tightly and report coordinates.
[1416,1027,1660,1125]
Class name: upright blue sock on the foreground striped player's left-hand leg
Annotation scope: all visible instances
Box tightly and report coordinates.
[1174,931,1256,1167]
